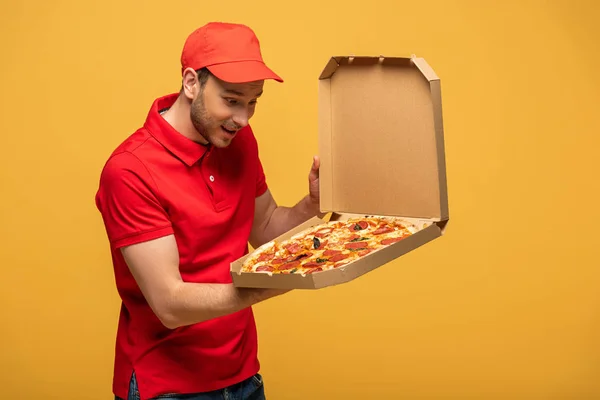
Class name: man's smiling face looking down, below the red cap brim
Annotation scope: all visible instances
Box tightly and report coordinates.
[190,69,264,147]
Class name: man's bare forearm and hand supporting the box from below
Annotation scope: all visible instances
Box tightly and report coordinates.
[159,282,285,329]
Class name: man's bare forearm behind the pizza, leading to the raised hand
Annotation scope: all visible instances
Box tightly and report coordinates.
[261,195,325,243]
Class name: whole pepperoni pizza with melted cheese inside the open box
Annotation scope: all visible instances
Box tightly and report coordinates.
[241,216,426,275]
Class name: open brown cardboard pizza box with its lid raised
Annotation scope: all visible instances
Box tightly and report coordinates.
[231,56,449,289]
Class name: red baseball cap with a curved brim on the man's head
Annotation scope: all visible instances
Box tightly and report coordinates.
[181,22,283,83]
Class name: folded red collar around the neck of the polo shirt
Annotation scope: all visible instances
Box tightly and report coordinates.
[144,93,212,166]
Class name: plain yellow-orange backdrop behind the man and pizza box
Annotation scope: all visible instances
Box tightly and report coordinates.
[0,0,600,400]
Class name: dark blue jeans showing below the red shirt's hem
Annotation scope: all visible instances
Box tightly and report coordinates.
[115,374,266,400]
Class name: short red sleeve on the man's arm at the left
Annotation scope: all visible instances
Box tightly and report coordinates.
[96,152,173,248]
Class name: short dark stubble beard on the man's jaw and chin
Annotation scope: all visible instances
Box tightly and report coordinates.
[190,92,241,147]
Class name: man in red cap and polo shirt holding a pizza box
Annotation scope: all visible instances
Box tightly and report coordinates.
[96,23,320,399]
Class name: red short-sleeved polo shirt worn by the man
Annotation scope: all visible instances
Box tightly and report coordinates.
[96,94,267,399]
